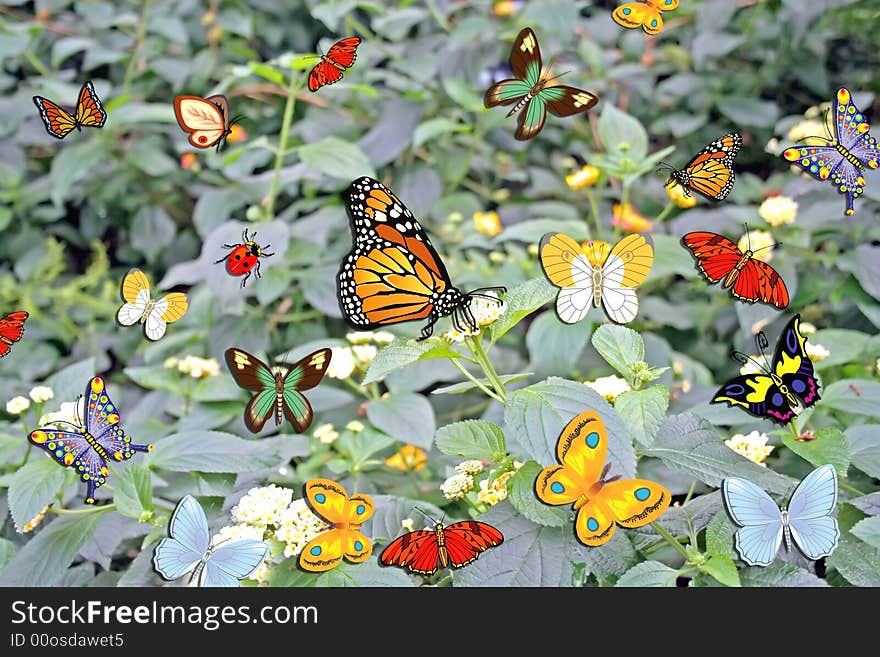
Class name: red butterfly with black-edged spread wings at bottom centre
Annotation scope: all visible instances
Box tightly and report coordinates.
[379,510,504,575]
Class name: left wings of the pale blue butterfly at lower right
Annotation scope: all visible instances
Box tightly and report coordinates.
[721,477,782,566]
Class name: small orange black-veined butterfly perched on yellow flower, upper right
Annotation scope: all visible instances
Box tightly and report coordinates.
[661,132,742,201]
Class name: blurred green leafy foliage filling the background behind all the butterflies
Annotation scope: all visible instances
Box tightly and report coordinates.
[0,0,880,586]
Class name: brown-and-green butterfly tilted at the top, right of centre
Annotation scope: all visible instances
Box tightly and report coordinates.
[485,27,599,141]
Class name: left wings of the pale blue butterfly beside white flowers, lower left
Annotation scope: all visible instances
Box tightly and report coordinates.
[153,495,211,580]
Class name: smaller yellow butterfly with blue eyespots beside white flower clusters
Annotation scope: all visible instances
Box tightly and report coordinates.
[299,479,375,572]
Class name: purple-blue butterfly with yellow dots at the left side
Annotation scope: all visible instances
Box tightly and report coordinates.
[30,376,153,504]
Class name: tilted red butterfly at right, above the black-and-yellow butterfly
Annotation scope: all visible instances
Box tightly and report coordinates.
[681,231,788,310]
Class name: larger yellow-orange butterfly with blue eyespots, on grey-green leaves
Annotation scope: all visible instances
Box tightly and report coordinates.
[535,411,672,547]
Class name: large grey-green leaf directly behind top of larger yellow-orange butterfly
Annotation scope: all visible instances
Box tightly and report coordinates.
[504,377,636,477]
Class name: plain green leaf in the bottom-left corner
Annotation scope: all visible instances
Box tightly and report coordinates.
[0,511,105,586]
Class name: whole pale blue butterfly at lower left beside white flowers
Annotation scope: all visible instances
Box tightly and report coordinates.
[153,495,269,586]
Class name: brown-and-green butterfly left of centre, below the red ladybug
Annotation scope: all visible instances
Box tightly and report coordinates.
[226,347,332,433]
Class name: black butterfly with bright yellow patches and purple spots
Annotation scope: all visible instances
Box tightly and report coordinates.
[711,315,821,424]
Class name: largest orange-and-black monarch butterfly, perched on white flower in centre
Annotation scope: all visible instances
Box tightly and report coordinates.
[337,176,506,339]
